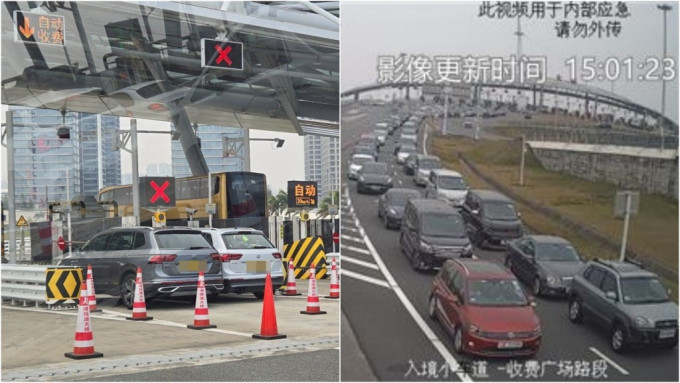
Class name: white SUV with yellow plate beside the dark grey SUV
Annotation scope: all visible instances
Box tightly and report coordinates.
[201,227,283,299]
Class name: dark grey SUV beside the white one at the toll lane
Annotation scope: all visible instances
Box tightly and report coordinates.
[59,227,224,309]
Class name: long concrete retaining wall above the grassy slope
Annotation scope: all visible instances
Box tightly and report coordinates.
[527,141,678,199]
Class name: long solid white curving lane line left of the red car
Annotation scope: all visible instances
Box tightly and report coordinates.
[345,190,472,382]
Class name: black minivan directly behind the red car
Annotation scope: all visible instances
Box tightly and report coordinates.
[399,199,472,270]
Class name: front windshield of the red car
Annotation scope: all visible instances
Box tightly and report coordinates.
[468,279,528,306]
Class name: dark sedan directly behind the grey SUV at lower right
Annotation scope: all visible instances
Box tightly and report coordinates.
[505,235,585,296]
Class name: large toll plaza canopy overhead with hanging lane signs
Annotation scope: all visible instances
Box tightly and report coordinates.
[2,1,339,173]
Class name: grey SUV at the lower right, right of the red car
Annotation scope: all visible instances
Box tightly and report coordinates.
[569,259,678,352]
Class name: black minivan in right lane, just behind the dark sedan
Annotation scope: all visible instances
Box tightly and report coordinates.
[461,190,524,248]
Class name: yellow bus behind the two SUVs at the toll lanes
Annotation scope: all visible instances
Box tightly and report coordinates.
[98,172,269,236]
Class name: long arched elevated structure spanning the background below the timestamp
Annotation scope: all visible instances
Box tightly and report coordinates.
[341,79,678,134]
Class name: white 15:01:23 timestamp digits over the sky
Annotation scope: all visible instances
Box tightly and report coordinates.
[564,56,677,82]
